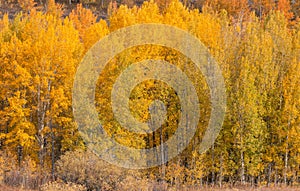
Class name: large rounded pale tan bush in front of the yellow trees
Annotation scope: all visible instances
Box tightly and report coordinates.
[56,150,124,190]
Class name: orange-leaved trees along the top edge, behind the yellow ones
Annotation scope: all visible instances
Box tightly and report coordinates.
[0,0,300,19]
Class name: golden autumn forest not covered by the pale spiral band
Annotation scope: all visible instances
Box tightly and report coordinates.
[0,0,300,190]
